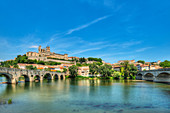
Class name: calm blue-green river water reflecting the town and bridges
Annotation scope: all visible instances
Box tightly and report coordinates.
[0,79,170,113]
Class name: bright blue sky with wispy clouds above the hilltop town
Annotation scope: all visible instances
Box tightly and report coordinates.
[0,0,170,63]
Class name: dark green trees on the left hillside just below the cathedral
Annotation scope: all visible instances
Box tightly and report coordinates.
[1,55,61,68]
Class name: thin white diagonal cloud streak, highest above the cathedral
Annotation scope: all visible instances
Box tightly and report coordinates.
[66,15,111,35]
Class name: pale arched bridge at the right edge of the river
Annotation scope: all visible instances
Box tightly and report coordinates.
[136,68,170,83]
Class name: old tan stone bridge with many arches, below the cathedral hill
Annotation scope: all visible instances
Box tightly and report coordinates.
[0,67,66,83]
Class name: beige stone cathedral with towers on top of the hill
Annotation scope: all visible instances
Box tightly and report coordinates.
[26,46,68,61]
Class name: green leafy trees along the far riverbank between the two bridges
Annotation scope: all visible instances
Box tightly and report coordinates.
[69,61,137,79]
